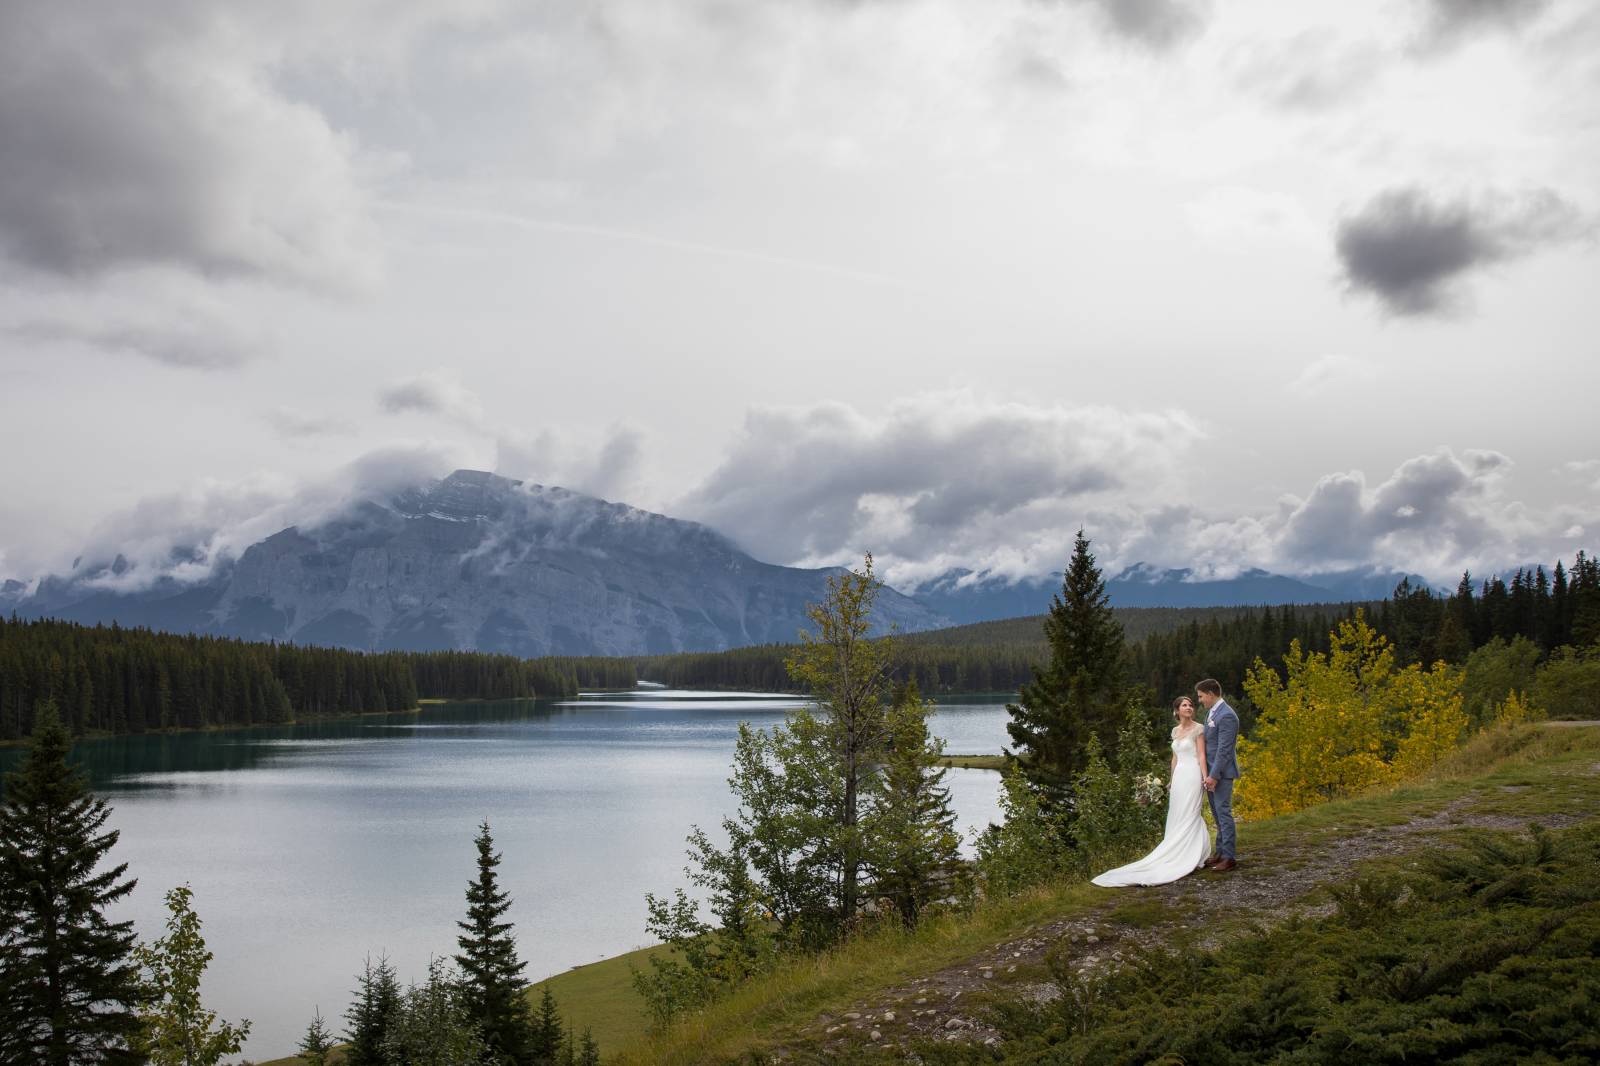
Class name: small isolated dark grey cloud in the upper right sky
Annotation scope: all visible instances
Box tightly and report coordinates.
[1334,189,1589,315]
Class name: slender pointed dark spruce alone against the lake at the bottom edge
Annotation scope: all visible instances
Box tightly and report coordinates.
[456,820,538,1066]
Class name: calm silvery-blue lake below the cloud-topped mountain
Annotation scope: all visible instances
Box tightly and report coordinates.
[0,690,1010,1058]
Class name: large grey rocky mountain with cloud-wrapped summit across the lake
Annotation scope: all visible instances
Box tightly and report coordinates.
[10,471,949,656]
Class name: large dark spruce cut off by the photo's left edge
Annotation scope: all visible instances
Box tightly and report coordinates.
[0,699,144,1066]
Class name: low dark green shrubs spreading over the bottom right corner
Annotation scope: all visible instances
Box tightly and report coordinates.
[928,826,1600,1066]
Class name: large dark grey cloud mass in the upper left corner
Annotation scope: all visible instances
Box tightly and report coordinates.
[0,0,376,288]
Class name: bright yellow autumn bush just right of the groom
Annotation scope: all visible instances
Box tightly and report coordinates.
[1235,611,1467,818]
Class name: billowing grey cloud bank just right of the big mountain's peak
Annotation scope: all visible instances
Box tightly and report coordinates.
[668,394,1200,581]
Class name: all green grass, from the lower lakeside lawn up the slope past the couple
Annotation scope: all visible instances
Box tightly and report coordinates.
[262,727,1600,1066]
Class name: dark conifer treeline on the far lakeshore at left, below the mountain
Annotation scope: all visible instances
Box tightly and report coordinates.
[0,616,585,739]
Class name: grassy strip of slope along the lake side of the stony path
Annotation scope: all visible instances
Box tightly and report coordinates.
[606,728,1600,1064]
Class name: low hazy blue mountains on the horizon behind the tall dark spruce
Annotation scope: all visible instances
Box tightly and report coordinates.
[915,563,1427,624]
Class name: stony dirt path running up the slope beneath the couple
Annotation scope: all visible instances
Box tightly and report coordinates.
[776,797,1578,1060]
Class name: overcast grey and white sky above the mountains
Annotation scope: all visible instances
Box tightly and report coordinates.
[0,0,1600,584]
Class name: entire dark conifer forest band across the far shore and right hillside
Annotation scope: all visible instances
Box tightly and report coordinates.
[0,552,1600,739]
